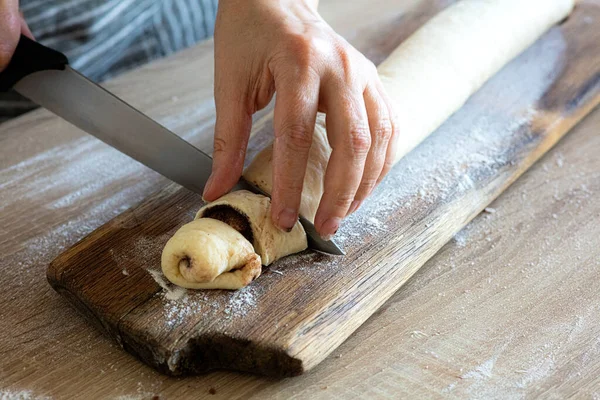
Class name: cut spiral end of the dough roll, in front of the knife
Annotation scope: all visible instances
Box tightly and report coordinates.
[162,190,307,290]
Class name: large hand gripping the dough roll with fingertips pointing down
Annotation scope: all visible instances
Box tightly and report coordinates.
[204,0,396,238]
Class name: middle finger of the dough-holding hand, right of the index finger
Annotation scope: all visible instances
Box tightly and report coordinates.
[315,87,371,239]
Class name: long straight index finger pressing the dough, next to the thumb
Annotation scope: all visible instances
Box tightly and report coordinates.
[271,72,319,231]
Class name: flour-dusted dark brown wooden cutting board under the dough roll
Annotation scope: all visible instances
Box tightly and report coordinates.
[48,0,600,376]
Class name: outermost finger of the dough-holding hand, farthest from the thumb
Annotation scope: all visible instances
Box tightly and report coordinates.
[348,85,393,214]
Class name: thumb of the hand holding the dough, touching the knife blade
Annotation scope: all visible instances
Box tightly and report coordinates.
[203,85,252,201]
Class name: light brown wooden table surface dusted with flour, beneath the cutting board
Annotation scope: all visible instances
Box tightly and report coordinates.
[0,0,600,399]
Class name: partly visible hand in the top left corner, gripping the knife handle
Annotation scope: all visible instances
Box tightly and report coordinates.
[0,0,33,72]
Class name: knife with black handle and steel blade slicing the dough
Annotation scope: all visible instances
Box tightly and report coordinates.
[0,35,344,255]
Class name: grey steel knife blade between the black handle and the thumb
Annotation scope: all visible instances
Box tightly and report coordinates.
[14,66,212,193]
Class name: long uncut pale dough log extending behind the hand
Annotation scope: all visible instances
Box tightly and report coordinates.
[377,0,575,161]
